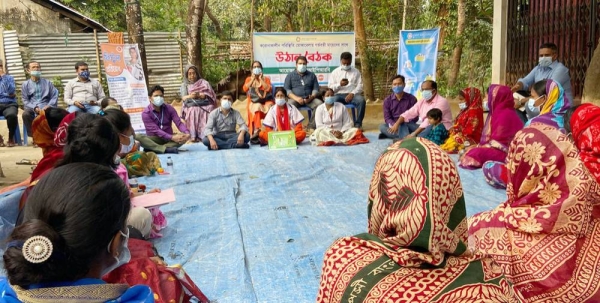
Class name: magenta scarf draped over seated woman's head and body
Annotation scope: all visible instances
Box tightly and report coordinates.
[479,84,523,149]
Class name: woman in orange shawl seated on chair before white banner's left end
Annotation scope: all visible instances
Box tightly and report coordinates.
[243,61,275,144]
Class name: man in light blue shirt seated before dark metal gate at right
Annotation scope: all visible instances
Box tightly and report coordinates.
[511,43,573,108]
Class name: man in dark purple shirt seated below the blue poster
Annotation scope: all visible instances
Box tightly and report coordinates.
[379,75,417,139]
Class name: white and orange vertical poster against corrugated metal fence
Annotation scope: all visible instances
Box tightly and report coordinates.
[100,43,149,133]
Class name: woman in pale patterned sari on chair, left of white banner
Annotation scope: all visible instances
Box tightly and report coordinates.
[179,65,217,142]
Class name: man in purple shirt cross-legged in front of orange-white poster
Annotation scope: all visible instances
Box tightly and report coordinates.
[135,85,190,154]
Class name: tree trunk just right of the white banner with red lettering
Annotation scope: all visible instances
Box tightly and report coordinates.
[352,0,375,101]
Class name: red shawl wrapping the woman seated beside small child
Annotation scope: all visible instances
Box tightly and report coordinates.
[450,87,483,142]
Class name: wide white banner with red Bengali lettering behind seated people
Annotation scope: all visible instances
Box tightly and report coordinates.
[252,32,355,86]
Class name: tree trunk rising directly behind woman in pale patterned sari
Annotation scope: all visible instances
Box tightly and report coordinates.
[185,0,206,74]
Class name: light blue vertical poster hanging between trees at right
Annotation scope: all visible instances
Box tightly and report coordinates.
[398,28,440,99]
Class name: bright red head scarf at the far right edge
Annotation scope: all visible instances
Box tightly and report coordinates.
[570,103,600,183]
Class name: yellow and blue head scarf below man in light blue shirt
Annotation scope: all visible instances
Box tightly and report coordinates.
[527,79,571,128]
